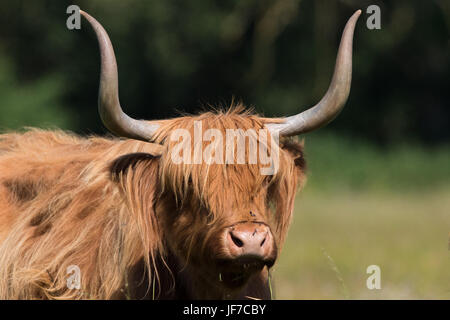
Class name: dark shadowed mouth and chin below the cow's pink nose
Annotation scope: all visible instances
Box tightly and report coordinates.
[215,256,274,289]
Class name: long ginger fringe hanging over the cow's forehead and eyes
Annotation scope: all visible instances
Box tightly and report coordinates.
[155,103,306,252]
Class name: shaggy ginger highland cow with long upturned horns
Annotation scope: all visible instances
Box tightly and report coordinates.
[0,11,361,299]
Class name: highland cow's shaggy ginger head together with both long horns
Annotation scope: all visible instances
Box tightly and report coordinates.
[81,10,361,296]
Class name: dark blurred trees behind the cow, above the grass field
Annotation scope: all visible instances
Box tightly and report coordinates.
[0,0,450,144]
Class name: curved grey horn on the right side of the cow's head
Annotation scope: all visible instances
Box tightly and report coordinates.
[267,10,361,136]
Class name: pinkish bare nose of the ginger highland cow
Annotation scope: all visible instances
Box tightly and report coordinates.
[227,222,274,260]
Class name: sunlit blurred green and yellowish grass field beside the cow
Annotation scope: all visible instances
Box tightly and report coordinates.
[273,137,450,299]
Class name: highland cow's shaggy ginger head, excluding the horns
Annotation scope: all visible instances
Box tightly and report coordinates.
[154,111,304,289]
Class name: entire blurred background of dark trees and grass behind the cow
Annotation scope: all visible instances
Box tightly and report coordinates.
[0,0,450,299]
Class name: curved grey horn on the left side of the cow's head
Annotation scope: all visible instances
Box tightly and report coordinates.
[80,10,159,141]
